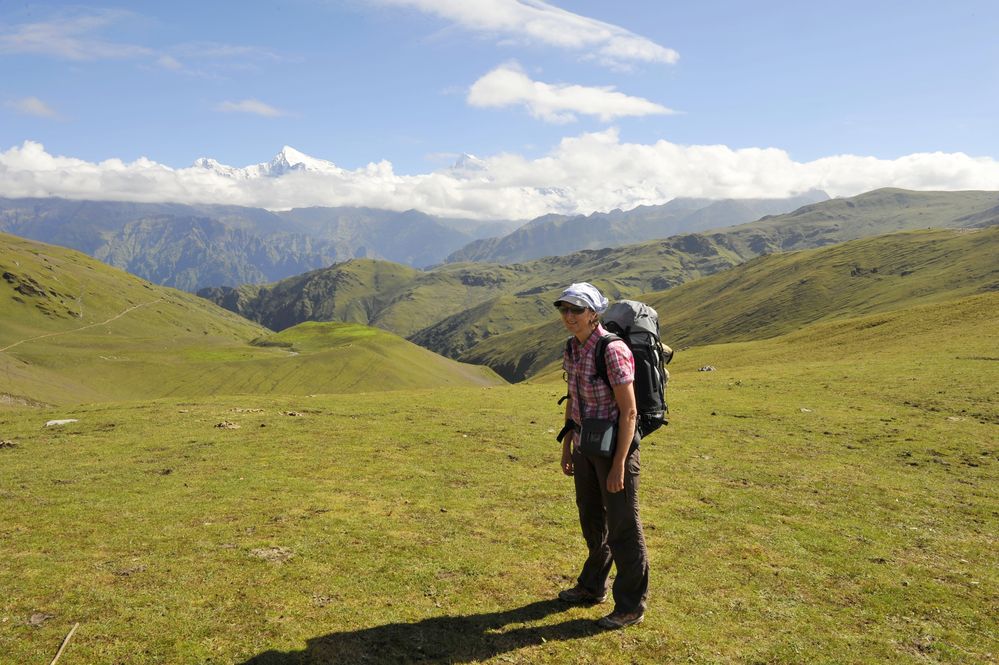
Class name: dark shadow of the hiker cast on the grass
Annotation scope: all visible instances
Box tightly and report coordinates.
[241,600,603,665]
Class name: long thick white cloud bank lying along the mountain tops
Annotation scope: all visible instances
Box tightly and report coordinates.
[0,137,999,219]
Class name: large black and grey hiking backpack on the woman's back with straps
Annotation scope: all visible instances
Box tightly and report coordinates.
[595,300,673,438]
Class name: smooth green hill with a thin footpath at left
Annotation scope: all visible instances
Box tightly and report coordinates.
[0,235,501,404]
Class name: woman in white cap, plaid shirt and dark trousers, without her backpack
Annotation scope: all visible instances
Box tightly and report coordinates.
[555,282,649,628]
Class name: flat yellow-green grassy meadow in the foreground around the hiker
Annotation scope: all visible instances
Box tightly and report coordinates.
[0,294,999,665]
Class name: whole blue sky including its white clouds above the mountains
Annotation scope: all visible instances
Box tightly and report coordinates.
[0,0,999,217]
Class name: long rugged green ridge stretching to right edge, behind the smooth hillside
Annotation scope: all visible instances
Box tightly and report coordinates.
[201,189,999,380]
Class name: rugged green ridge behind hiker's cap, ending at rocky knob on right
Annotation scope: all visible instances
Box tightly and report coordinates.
[199,235,744,350]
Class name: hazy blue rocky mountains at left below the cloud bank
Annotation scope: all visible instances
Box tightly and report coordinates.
[0,198,516,292]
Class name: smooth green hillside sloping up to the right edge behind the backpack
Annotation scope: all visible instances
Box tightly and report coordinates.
[461,227,999,380]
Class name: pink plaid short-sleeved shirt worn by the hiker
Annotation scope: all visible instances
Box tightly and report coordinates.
[562,325,635,423]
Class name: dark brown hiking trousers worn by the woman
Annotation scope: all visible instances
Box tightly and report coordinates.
[572,444,649,612]
